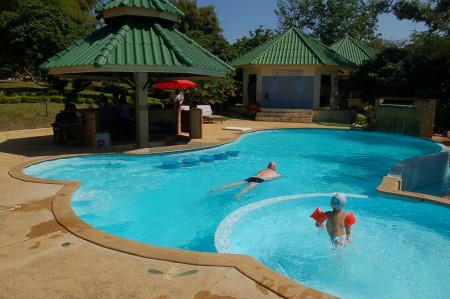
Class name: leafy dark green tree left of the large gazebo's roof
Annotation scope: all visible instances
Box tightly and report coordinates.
[0,0,96,75]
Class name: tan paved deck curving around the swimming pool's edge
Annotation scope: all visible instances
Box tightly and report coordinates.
[0,119,450,299]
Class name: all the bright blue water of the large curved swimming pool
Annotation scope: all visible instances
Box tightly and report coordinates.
[25,129,450,298]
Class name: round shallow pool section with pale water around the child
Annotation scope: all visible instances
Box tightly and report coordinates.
[216,193,450,298]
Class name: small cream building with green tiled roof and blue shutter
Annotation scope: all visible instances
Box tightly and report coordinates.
[232,28,356,115]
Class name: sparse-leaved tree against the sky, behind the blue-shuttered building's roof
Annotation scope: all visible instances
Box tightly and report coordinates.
[275,0,389,45]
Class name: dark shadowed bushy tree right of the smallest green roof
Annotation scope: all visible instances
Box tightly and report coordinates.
[351,33,450,132]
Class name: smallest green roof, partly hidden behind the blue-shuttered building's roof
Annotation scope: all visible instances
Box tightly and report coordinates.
[331,36,377,65]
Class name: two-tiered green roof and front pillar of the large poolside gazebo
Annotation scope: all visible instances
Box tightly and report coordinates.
[40,0,234,147]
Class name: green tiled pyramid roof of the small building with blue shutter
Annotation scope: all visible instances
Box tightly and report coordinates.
[232,28,354,67]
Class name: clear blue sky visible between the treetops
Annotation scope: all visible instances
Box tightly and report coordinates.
[197,0,425,44]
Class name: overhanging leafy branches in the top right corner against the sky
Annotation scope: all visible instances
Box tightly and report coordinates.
[392,0,450,35]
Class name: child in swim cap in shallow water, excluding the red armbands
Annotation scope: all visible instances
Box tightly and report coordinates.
[319,193,352,246]
